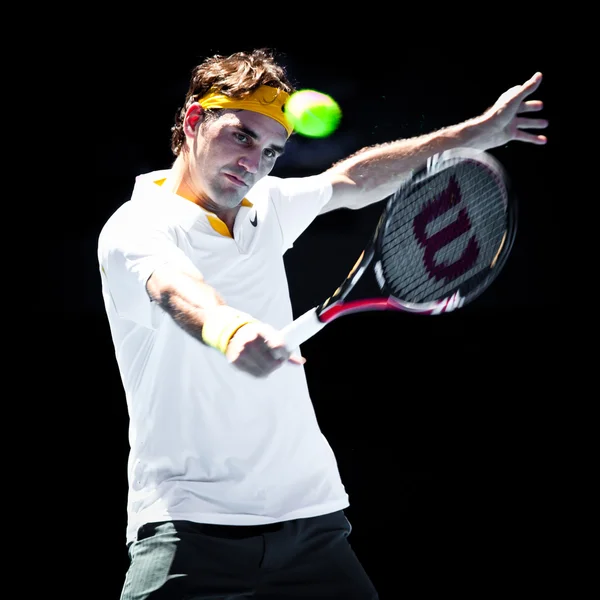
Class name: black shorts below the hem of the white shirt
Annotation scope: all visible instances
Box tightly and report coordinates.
[121,511,378,600]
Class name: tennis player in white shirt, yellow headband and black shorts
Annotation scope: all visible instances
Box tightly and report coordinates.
[98,49,547,600]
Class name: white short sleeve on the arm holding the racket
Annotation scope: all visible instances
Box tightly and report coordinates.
[98,202,198,329]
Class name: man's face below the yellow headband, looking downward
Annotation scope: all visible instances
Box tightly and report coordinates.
[188,110,287,210]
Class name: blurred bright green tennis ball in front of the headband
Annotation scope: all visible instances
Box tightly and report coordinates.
[284,90,342,138]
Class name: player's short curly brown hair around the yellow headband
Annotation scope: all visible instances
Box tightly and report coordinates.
[171,48,296,156]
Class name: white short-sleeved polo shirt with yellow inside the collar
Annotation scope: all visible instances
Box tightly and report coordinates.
[98,171,348,542]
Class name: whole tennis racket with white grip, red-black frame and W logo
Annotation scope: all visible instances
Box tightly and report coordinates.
[283,148,517,349]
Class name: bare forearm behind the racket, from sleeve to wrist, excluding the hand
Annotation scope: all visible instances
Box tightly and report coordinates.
[326,119,477,210]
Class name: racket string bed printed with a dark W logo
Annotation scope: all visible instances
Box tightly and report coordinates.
[380,161,507,303]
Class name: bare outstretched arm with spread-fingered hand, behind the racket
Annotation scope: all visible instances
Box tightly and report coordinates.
[321,73,548,213]
